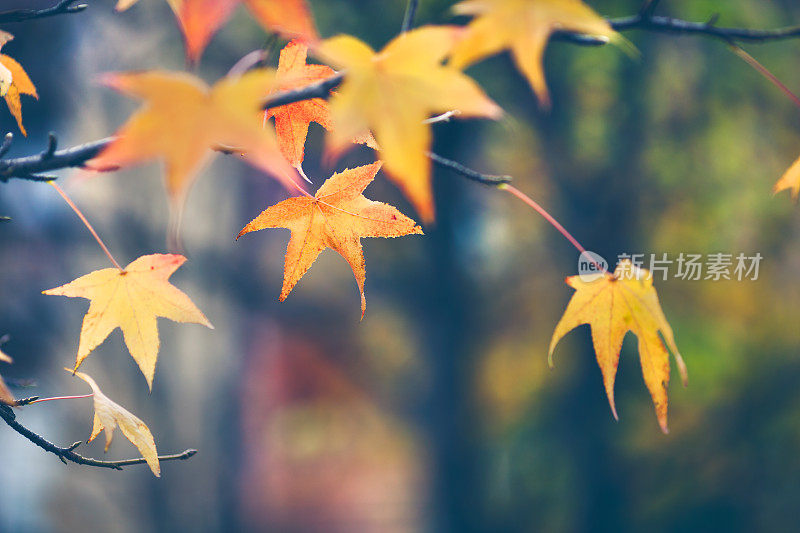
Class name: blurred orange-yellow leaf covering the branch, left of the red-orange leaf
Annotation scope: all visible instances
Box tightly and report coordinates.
[87,70,295,209]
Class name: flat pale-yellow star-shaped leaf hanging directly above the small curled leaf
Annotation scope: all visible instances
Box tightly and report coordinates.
[44,254,213,389]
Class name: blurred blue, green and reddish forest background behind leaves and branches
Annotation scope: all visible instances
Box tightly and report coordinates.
[0,0,800,532]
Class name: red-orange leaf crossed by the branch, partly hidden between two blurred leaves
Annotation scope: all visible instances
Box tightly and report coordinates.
[266,41,378,167]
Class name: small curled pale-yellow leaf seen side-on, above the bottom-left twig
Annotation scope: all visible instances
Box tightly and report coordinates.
[69,368,161,477]
